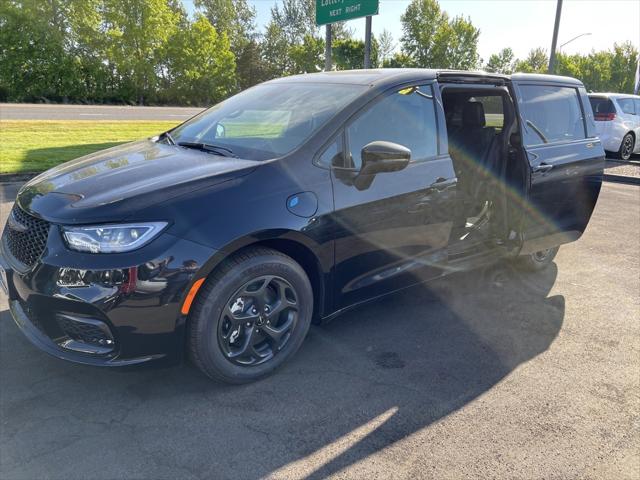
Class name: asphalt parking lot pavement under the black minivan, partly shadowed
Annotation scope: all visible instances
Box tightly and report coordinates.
[0,184,640,480]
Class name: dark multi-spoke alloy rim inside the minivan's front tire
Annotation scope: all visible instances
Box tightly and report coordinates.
[218,275,298,365]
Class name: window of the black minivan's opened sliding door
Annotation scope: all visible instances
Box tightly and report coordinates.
[520,85,586,146]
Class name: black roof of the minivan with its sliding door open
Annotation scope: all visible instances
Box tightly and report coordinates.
[269,68,582,86]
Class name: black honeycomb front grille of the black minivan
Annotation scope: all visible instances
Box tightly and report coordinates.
[4,205,50,267]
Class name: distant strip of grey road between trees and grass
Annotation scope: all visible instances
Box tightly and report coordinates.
[0,103,202,121]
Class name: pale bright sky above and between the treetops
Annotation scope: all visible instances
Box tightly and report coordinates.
[183,0,640,61]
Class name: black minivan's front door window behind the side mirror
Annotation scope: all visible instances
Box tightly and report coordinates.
[347,85,438,168]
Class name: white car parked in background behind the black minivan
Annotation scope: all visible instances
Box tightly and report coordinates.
[589,93,640,160]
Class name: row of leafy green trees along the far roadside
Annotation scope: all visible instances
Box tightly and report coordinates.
[0,0,638,105]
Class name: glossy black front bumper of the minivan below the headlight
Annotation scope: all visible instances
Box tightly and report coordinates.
[0,226,215,367]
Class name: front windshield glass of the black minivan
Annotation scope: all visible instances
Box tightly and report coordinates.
[171,83,366,160]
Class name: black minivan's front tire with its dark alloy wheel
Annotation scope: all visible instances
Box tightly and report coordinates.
[187,248,313,384]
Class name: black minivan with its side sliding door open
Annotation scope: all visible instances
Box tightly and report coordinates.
[0,69,604,383]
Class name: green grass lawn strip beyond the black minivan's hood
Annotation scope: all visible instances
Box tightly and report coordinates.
[0,120,176,173]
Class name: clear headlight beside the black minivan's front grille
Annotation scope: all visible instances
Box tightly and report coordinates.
[62,222,167,253]
